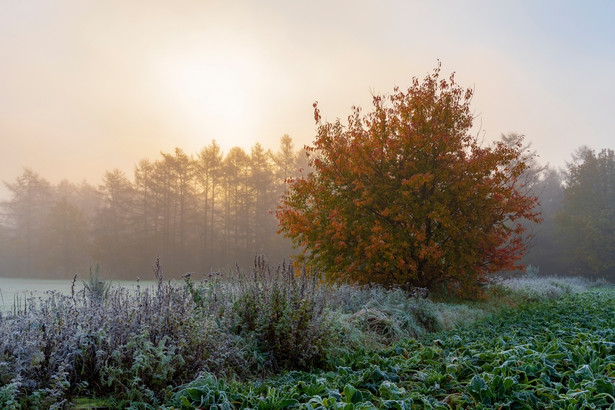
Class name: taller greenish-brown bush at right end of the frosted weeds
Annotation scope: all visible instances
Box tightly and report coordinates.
[228,257,331,371]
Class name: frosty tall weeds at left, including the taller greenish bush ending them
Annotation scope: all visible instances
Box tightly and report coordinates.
[0,258,332,408]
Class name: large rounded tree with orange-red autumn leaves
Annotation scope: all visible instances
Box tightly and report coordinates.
[277,66,539,295]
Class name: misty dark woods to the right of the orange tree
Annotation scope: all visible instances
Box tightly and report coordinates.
[523,146,615,282]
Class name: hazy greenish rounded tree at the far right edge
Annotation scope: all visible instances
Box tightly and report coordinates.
[557,147,615,280]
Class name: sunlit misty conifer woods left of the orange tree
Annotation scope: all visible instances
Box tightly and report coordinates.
[0,135,307,279]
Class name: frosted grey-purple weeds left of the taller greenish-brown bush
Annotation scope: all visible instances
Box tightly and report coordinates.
[0,262,227,407]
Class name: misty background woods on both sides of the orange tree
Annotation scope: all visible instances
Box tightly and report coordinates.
[0,134,615,281]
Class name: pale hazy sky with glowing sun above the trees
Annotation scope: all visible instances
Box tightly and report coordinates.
[0,0,615,197]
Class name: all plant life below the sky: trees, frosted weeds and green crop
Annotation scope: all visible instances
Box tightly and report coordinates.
[0,67,615,409]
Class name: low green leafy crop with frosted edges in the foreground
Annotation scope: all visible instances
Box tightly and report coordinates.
[173,289,615,409]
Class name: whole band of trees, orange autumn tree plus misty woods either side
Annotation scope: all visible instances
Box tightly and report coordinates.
[0,81,615,286]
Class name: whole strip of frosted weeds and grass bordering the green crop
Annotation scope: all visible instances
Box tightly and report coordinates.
[0,259,591,408]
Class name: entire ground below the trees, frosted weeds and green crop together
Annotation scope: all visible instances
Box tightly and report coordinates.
[0,264,615,409]
